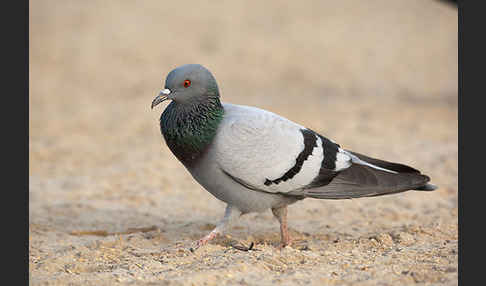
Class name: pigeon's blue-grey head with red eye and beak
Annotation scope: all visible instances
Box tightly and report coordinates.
[152,64,219,108]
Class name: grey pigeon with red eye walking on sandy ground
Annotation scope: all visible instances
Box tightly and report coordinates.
[151,64,437,249]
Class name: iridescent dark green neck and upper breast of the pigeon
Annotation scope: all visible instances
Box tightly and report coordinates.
[160,97,224,166]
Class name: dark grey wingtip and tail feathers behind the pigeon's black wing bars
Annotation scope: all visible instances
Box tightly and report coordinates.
[304,151,437,199]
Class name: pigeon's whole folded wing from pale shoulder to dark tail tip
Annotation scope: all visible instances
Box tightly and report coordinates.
[214,104,435,199]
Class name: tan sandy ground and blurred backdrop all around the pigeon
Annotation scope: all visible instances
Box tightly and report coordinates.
[29,0,458,285]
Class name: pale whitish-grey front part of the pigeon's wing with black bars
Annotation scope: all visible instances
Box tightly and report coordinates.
[213,104,351,193]
